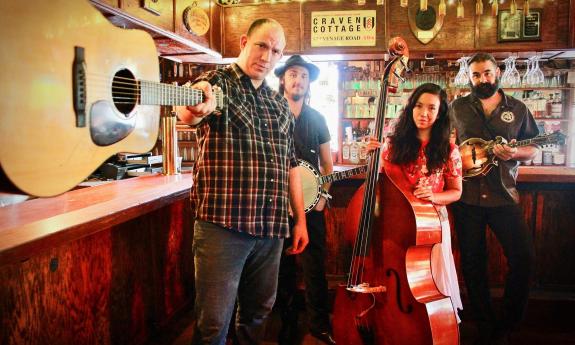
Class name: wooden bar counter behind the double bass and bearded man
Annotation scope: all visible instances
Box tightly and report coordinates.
[326,166,575,299]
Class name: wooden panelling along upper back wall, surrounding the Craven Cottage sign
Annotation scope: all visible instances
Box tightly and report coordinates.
[219,0,575,58]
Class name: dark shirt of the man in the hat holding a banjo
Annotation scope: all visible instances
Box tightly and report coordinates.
[294,104,331,171]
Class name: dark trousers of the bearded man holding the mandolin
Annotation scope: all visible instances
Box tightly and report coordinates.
[452,202,534,335]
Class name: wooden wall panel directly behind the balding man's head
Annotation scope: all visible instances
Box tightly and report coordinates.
[222,2,301,57]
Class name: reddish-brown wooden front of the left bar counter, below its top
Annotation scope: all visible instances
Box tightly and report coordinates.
[0,196,193,345]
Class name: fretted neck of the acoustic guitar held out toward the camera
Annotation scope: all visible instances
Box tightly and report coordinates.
[139,80,223,108]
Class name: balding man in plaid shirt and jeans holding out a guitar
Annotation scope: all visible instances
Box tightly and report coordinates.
[178,19,308,345]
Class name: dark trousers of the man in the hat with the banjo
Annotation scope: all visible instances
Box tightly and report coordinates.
[276,211,331,333]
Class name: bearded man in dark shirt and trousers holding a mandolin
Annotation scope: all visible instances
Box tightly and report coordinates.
[450,53,539,344]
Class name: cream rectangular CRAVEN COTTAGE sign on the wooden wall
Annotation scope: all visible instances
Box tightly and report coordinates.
[311,10,376,47]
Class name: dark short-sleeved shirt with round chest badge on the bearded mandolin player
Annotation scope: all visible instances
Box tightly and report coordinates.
[449,89,539,207]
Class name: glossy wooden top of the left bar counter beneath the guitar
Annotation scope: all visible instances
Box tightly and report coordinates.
[0,174,192,264]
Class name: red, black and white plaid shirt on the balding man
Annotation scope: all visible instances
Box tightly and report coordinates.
[191,64,297,237]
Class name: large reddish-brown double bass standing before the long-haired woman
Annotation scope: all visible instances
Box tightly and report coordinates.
[333,37,459,345]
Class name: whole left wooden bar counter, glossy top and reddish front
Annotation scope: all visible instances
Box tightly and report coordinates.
[0,174,193,344]
